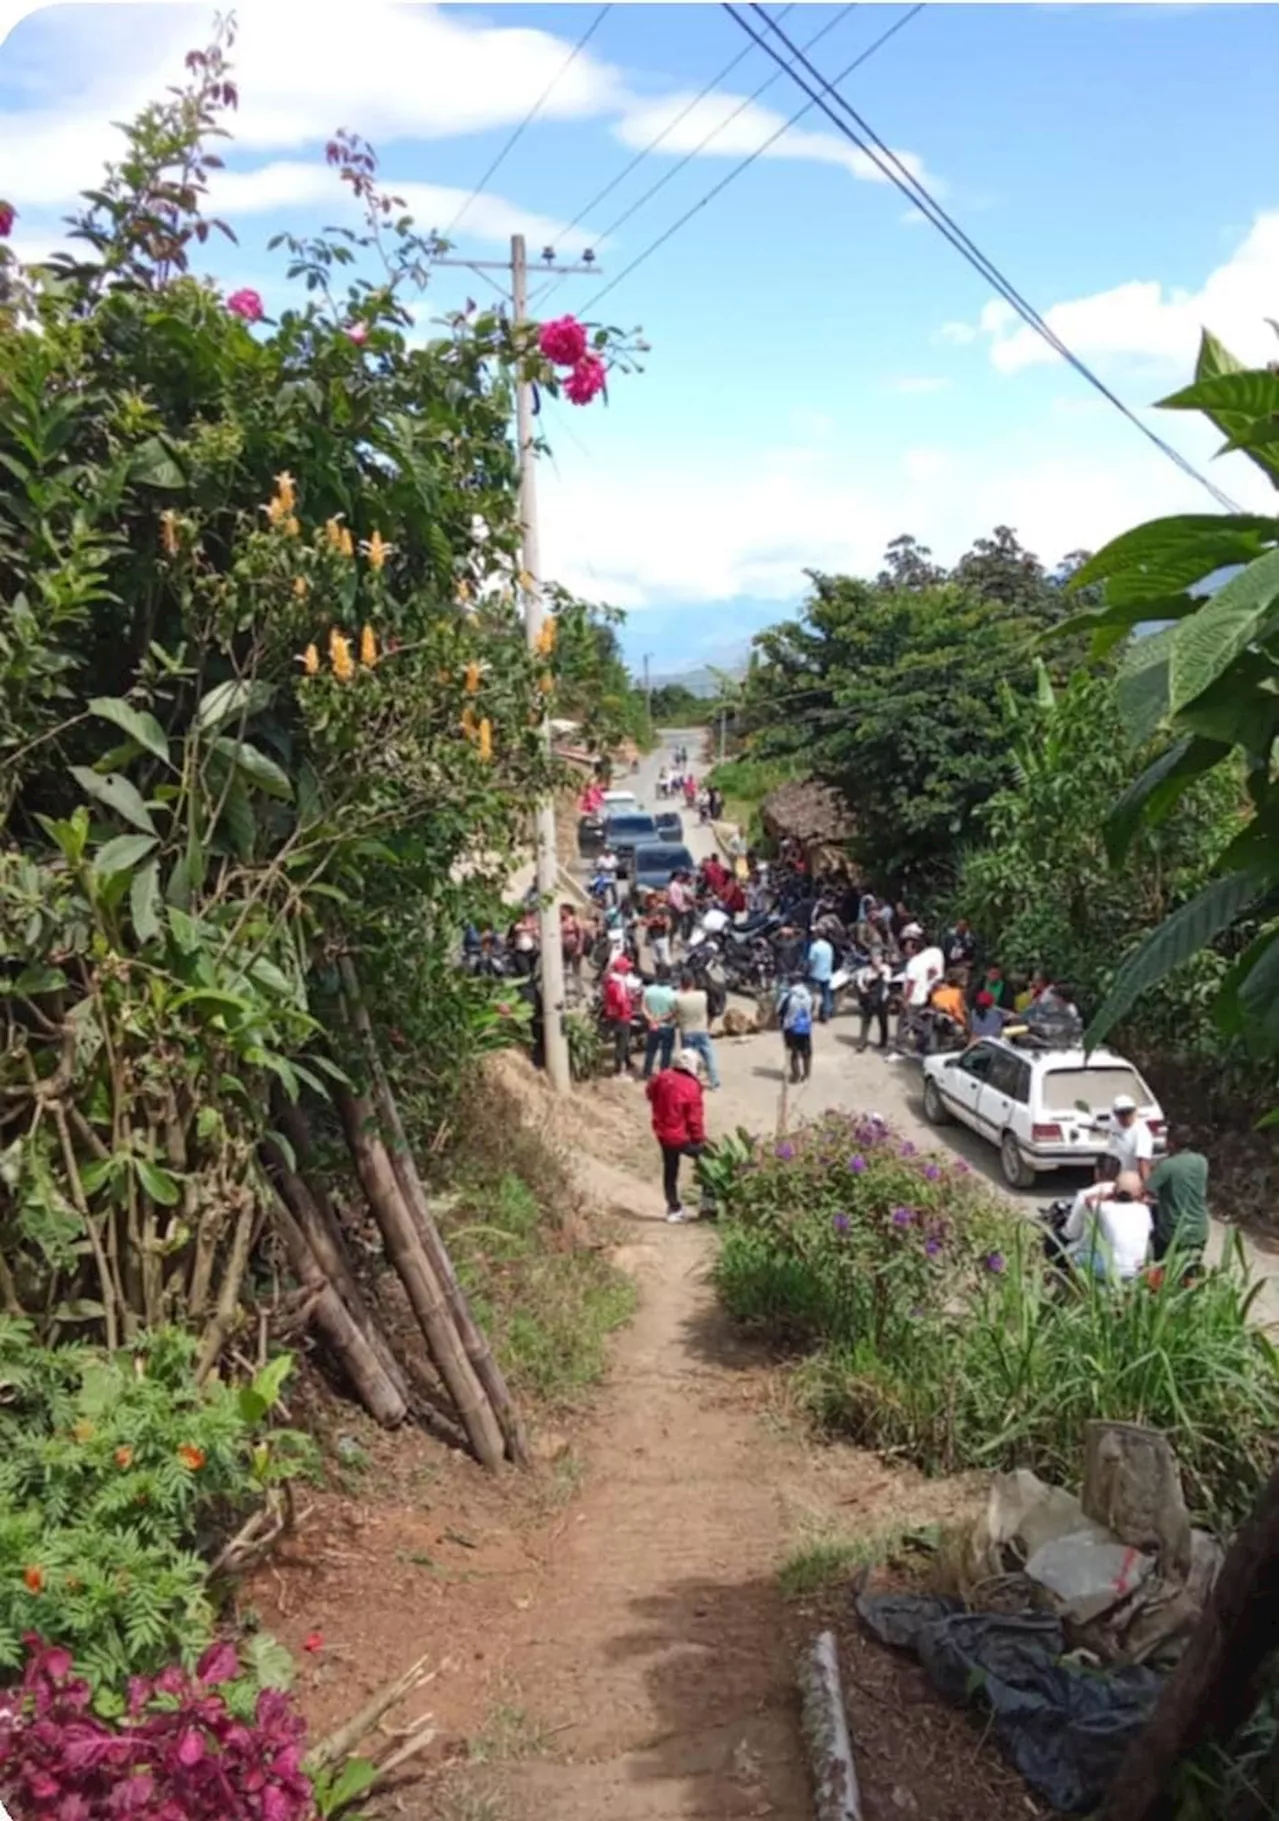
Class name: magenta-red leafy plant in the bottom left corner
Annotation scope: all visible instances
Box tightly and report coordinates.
[0,1635,313,1821]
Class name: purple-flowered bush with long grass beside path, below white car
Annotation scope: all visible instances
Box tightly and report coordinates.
[716,1114,1280,1521]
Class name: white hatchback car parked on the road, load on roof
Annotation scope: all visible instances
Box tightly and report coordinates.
[925,1036,1165,1189]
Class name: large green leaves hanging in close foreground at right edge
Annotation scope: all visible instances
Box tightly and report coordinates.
[1072,333,1280,1053]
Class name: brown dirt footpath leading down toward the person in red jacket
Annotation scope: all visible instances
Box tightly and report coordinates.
[480,1164,810,1821]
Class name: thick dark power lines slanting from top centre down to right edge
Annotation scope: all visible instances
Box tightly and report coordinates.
[731,0,1240,512]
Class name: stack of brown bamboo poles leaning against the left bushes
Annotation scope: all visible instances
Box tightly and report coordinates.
[260,958,530,1470]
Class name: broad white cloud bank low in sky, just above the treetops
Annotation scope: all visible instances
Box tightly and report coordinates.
[541,421,1273,612]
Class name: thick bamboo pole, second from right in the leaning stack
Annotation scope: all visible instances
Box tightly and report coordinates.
[333,1087,504,1470]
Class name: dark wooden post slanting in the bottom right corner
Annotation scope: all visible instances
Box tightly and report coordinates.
[1098,1468,1280,1821]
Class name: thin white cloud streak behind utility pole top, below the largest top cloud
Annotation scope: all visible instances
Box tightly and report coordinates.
[209,158,586,246]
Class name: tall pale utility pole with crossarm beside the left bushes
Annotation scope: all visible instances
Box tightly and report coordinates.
[432,233,601,1094]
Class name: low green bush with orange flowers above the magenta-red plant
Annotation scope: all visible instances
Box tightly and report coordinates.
[0,1318,310,1690]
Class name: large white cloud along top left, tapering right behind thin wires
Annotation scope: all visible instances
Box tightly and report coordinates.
[0,0,936,228]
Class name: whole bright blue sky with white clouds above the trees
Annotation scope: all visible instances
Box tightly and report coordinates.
[0,0,1280,670]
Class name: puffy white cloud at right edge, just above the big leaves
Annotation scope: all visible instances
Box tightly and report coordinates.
[968,211,1280,373]
